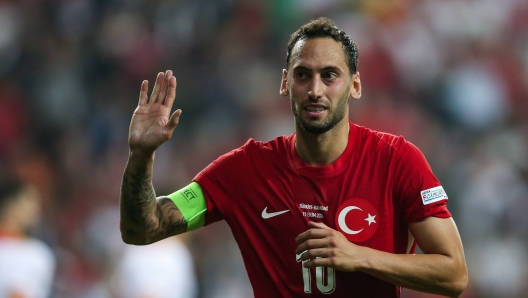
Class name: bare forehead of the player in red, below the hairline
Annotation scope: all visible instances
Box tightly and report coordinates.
[290,37,348,71]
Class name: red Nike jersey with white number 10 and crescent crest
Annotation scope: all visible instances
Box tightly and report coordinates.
[194,123,451,298]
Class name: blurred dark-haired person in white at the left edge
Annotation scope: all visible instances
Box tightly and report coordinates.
[0,179,55,298]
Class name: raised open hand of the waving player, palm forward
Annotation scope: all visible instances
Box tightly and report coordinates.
[128,70,182,154]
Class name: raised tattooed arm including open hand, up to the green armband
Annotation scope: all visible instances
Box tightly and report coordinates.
[119,70,187,245]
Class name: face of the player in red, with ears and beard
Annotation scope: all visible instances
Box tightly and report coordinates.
[280,38,361,134]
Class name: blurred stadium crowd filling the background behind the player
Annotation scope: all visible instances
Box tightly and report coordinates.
[0,0,528,298]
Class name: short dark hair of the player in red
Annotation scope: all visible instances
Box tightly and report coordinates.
[286,17,359,75]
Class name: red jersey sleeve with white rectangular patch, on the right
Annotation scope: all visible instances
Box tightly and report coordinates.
[393,140,451,222]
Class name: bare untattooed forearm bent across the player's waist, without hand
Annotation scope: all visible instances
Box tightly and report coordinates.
[359,248,467,297]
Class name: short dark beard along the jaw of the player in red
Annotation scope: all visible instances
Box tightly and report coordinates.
[290,88,350,135]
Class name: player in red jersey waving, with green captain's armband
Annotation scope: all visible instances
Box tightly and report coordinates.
[121,18,467,297]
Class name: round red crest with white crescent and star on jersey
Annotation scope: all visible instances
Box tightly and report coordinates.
[336,198,379,242]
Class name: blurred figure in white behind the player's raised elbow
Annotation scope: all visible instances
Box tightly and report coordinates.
[82,205,198,298]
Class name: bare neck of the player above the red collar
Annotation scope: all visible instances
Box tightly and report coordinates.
[295,118,350,166]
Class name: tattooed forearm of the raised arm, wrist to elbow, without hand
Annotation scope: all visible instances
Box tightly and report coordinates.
[119,152,159,244]
